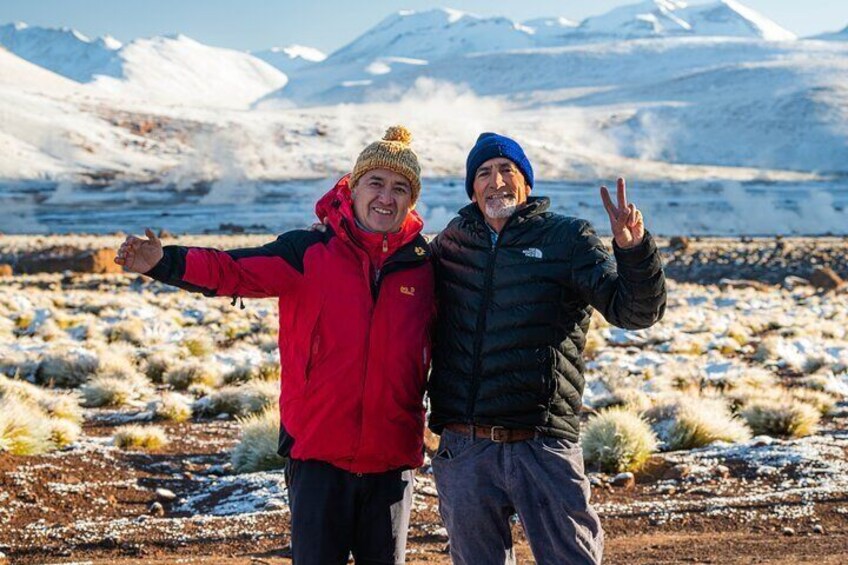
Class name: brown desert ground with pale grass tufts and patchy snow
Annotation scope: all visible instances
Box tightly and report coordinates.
[0,234,848,564]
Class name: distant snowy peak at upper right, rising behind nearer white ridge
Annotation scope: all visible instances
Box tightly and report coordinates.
[574,0,796,41]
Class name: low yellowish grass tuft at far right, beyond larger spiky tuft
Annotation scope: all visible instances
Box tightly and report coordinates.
[741,397,821,437]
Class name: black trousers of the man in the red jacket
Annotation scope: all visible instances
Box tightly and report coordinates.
[286,459,413,565]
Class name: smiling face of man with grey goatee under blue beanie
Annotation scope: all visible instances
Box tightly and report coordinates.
[471,157,530,232]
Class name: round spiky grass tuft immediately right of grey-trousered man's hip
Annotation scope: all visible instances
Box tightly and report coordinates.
[582,408,657,473]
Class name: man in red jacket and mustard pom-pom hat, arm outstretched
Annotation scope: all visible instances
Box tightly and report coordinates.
[116,127,435,565]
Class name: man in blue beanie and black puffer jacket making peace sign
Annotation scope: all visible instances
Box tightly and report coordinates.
[429,133,666,565]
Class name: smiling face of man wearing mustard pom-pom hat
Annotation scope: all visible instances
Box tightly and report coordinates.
[351,169,412,233]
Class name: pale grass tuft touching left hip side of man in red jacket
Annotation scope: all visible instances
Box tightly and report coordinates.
[231,408,285,473]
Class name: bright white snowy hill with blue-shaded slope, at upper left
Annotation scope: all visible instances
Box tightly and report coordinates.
[0,23,288,108]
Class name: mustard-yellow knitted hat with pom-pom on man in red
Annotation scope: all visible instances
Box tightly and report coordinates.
[350,126,421,204]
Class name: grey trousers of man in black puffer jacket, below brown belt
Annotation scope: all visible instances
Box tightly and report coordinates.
[433,430,604,565]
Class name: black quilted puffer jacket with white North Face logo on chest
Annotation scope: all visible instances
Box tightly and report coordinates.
[429,198,666,441]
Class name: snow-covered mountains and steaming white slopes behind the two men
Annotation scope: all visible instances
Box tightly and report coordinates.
[0,0,848,233]
